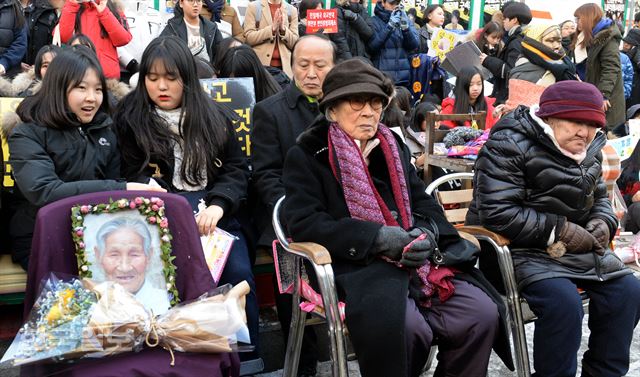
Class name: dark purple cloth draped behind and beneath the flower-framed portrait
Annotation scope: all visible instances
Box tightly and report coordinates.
[21,191,240,377]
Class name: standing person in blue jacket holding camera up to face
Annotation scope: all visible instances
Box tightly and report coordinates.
[368,0,419,87]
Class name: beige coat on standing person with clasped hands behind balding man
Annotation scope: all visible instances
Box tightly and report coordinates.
[244,0,298,77]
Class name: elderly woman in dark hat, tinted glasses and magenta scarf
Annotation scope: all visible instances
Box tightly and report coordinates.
[283,59,510,377]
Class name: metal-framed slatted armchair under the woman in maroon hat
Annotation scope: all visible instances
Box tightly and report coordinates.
[426,173,589,377]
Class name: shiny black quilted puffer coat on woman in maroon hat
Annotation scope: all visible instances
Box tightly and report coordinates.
[466,106,628,288]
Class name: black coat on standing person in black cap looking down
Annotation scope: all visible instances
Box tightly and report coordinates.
[482,26,524,105]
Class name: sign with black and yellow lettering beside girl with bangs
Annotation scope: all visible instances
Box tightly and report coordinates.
[200,77,256,157]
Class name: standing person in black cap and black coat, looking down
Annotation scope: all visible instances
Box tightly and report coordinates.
[480,2,532,105]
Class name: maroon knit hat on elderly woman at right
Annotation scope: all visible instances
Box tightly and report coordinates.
[536,81,607,127]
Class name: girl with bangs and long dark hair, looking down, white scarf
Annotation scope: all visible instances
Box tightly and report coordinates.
[114,36,258,345]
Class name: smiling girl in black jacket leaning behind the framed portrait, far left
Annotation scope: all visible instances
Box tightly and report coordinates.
[3,47,164,270]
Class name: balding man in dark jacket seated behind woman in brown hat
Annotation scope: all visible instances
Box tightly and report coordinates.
[251,34,336,376]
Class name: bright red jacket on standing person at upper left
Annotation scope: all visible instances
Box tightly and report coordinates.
[60,0,132,79]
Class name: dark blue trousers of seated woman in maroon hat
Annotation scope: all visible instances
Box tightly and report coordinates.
[522,275,640,377]
